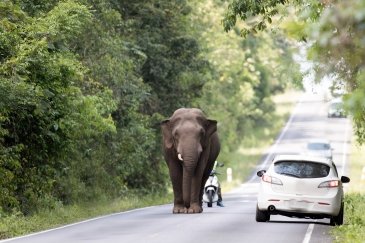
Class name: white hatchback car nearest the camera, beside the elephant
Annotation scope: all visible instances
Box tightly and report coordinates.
[256,155,350,225]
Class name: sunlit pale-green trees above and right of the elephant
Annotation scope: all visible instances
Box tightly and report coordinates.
[192,1,300,156]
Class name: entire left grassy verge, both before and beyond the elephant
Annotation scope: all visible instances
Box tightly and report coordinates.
[0,89,298,239]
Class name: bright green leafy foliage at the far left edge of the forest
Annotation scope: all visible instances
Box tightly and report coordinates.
[0,1,115,214]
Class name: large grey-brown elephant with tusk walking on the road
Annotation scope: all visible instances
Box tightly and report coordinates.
[161,108,220,214]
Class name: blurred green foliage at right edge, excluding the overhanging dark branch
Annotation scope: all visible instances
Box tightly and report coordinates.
[307,1,365,143]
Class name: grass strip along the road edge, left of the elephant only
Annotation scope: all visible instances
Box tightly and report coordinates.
[0,194,172,239]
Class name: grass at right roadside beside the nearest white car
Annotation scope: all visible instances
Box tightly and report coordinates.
[331,141,365,243]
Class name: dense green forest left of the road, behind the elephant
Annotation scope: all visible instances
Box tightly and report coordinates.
[0,0,301,215]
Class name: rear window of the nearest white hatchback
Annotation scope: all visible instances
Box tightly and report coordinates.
[274,161,330,178]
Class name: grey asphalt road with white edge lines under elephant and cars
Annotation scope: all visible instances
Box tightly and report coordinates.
[0,94,352,243]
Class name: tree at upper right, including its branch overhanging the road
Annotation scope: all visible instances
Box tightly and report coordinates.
[223,0,365,143]
